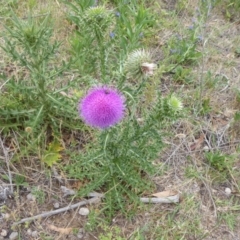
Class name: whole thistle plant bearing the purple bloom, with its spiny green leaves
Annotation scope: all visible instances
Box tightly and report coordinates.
[66,47,182,216]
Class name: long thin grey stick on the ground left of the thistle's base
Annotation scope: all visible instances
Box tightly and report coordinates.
[12,197,100,226]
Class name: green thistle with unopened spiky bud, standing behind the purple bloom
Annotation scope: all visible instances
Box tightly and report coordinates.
[69,5,113,80]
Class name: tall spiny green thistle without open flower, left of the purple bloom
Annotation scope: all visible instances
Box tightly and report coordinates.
[0,14,76,133]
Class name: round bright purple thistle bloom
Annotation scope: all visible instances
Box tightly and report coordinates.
[78,87,125,129]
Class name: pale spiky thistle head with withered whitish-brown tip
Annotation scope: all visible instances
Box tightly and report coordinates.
[124,49,157,79]
